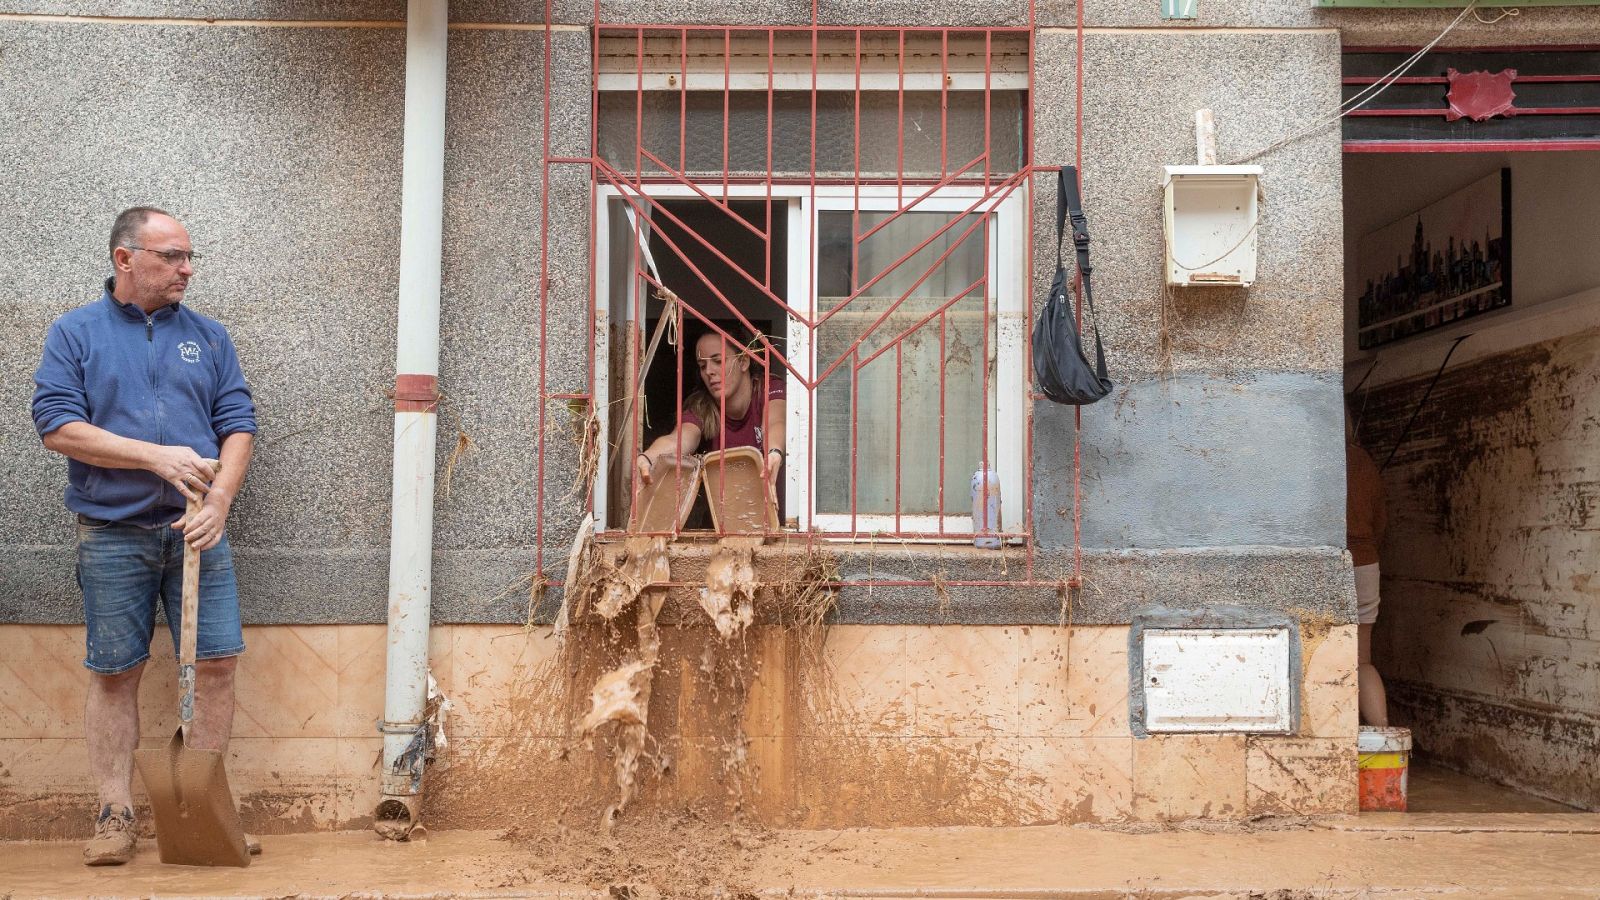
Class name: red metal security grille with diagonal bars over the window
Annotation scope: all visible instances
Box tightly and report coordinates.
[534,0,1120,608]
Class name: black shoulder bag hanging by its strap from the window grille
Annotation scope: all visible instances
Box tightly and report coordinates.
[1034,165,1112,407]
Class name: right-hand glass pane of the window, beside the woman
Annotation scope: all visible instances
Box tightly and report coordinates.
[816,211,995,516]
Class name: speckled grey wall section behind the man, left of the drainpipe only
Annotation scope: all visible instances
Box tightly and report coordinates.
[0,19,403,621]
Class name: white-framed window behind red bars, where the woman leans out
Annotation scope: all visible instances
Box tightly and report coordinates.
[590,26,1030,540]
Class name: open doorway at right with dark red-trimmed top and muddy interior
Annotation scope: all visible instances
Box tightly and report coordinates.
[1344,48,1600,815]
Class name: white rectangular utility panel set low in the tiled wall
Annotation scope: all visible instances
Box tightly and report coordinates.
[1142,628,1294,733]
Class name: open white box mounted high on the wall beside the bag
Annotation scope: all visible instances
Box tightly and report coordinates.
[1162,165,1261,287]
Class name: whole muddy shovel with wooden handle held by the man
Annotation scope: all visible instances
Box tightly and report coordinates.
[133,460,250,866]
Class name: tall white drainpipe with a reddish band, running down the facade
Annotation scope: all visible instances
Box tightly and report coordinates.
[373,0,450,841]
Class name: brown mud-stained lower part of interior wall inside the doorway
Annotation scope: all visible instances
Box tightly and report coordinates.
[1362,323,1600,809]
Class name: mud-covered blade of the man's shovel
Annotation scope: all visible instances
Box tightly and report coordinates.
[133,729,250,868]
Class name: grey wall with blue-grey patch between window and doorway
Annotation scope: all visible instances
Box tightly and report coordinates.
[1034,26,1352,630]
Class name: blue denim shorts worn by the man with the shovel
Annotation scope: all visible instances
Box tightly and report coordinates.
[78,517,245,674]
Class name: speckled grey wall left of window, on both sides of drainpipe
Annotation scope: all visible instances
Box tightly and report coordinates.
[0,12,589,623]
